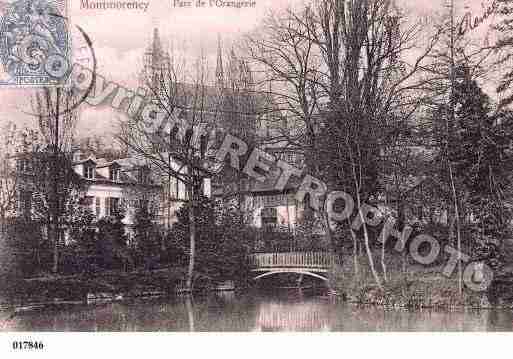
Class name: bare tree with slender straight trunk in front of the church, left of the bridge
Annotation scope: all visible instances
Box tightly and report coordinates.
[117,54,218,290]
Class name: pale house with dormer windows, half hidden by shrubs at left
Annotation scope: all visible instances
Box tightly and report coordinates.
[13,150,211,243]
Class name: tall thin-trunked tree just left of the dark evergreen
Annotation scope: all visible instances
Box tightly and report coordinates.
[422,0,491,293]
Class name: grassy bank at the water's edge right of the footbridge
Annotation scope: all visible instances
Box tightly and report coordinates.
[330,256,513,310]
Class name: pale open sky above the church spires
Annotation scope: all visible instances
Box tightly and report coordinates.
[0,0,496,136]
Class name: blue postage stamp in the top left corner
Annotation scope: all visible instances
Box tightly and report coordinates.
[0,0,71,87]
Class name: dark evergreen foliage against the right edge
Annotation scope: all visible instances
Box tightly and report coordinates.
[454,71,513,264]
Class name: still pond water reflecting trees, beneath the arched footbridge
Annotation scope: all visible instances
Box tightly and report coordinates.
[0,291,513,331]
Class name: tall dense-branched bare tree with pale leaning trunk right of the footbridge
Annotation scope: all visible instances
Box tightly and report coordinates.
[312,0,438,287]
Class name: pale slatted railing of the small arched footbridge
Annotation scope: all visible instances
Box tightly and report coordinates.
[251,252,336,269]
